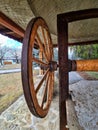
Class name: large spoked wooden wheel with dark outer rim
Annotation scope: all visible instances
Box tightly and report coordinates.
[22,17,54,118]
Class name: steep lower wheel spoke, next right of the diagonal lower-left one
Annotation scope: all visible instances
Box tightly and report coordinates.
[41,73,50,108]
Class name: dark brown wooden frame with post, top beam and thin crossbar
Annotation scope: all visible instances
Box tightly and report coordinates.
[57,9,98,130]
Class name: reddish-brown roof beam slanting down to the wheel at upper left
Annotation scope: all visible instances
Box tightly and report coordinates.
[0,12,25,37]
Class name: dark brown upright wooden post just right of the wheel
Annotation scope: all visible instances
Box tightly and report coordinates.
[57,15,69,130]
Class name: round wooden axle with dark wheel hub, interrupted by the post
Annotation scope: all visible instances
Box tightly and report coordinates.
[40,59,98,72]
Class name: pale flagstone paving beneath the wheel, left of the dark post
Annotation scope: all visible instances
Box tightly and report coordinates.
[0,96,59,130]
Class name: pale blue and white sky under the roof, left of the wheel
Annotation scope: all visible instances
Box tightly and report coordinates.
[0,34,22,49]
